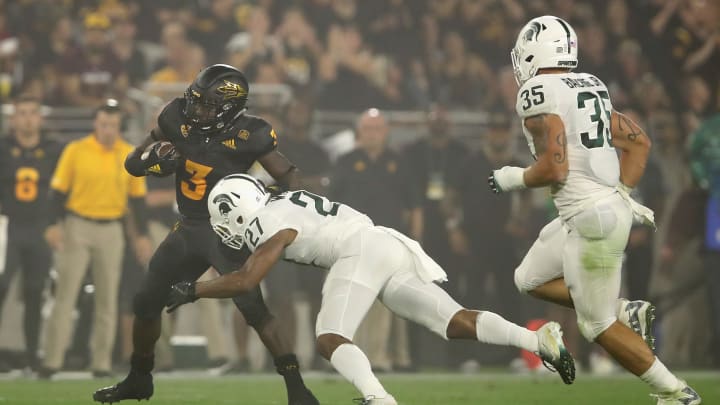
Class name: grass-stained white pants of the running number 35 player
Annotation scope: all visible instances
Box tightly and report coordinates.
[515,194,632,341]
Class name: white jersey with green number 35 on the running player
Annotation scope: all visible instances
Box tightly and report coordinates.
[516,73,620,219]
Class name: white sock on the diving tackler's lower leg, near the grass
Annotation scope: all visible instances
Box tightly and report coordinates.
[330,343,388,398]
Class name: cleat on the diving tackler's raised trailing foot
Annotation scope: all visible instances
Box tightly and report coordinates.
[535,322,575,384]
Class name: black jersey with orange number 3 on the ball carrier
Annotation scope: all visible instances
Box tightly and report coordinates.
[158,98,277,219]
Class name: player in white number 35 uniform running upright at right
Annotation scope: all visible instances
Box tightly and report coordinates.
[488,16,701,405]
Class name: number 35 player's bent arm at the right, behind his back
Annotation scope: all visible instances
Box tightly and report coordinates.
[610,111,651,188]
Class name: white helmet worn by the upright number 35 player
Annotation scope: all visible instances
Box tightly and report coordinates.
[510,15,578,86]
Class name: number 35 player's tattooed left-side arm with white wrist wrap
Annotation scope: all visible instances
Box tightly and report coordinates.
[488,114,568,193]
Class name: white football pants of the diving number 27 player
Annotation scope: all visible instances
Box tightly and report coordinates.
[315,228,462,340]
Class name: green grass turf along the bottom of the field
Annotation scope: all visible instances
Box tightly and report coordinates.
[0,373,720,405]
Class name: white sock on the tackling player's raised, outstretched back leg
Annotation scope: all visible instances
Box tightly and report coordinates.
[475,311,539,353]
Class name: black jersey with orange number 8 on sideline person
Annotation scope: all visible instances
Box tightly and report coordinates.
[0,136,63,221]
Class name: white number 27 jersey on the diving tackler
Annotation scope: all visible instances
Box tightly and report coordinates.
[241,190,374,268]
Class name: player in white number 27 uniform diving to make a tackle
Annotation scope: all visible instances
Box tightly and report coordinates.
[168,174,575,405]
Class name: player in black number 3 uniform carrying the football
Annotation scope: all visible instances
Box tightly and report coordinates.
[93,64,318,405]
